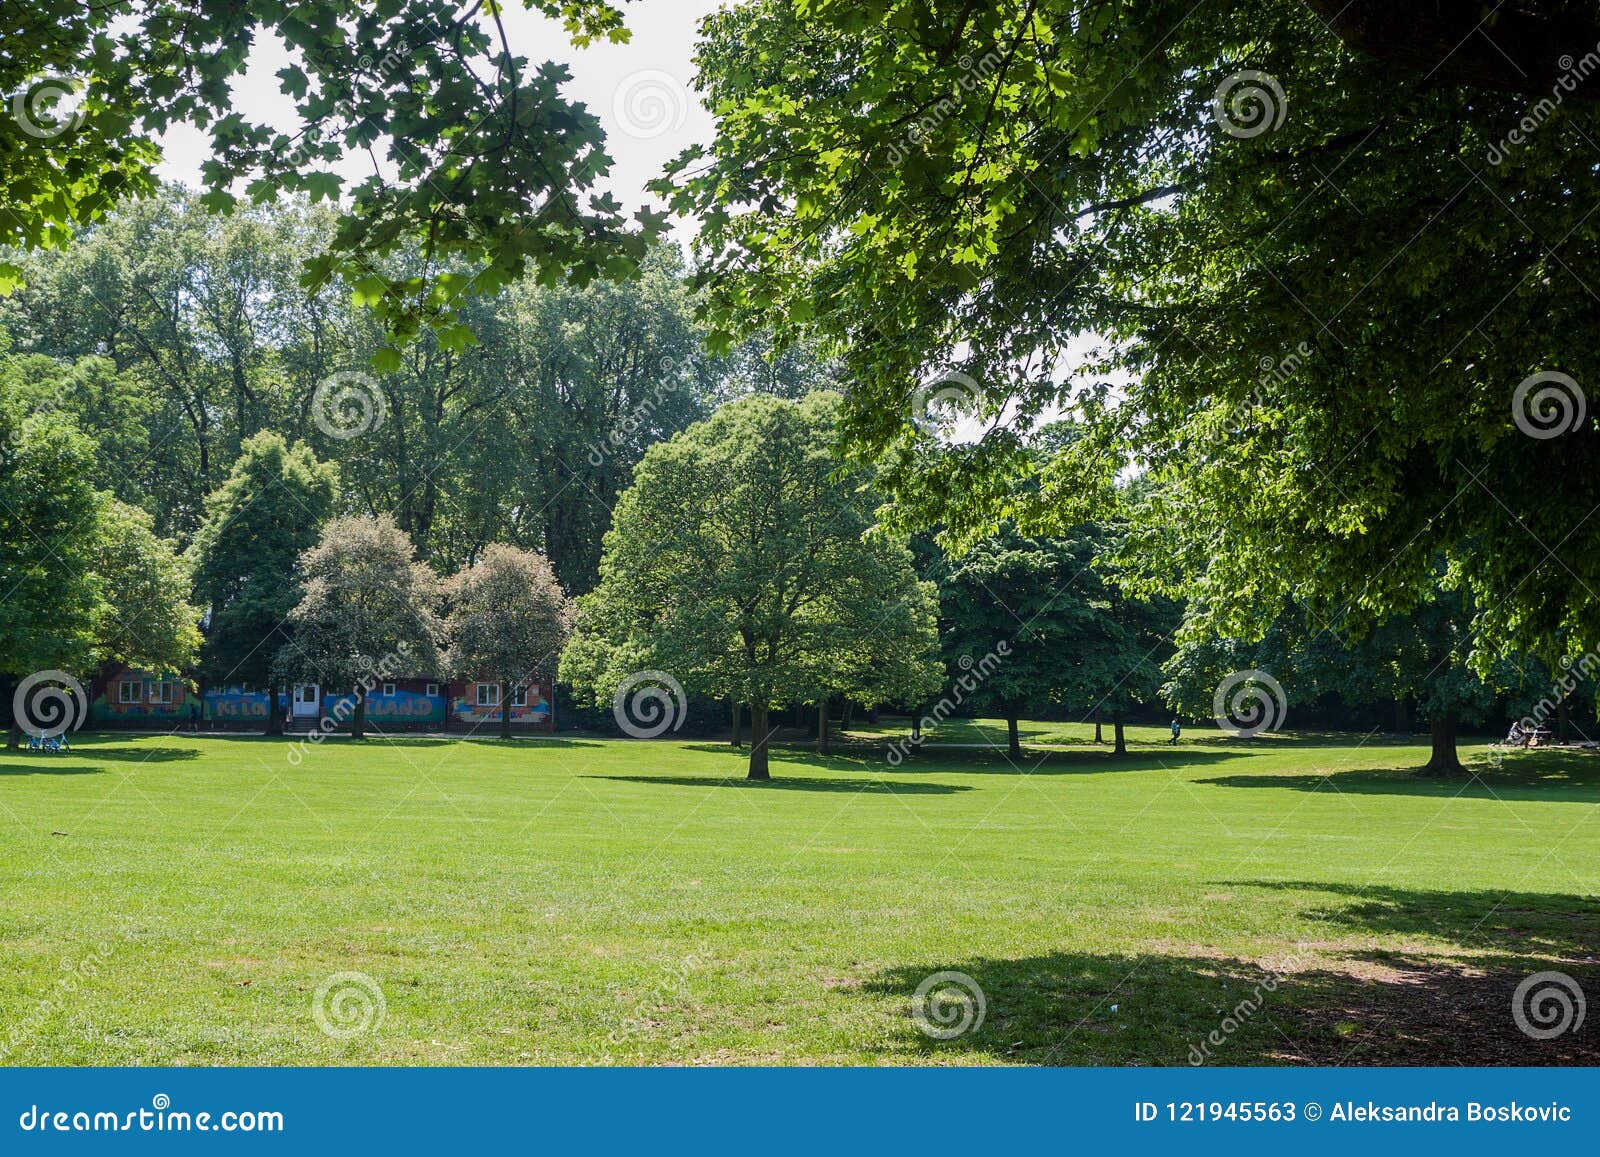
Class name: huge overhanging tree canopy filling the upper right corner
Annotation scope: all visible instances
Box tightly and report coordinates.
[677,0,1600,697]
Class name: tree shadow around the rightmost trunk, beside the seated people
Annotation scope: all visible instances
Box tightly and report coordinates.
[1195,751,1600,803]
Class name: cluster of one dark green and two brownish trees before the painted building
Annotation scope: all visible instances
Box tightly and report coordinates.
[190,432,573,738]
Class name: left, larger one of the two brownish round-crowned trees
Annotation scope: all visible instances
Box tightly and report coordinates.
[274,515,443,739]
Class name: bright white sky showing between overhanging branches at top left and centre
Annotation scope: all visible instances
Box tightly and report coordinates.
[158,0,720,242]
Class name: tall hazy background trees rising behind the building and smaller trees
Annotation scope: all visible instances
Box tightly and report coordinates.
[0,187,829,591]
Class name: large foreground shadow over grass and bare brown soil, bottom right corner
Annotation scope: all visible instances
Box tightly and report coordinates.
[862,952,1600,1066]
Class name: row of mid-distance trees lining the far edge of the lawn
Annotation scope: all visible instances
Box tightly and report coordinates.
[3,355,1568,778]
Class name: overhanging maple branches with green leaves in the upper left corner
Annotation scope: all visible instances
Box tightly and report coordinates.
[0,0,661,344]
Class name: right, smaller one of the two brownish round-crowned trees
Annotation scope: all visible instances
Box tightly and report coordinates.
[445,546,574,739]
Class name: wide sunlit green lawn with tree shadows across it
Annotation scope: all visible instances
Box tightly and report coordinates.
[0,723,1600,1064]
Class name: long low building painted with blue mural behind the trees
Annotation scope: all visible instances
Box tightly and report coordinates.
[90,666,555,733]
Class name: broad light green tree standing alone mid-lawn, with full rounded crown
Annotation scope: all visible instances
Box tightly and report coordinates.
[562,394,938,779]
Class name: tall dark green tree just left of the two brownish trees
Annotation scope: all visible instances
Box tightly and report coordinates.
[189,430,338,735]
